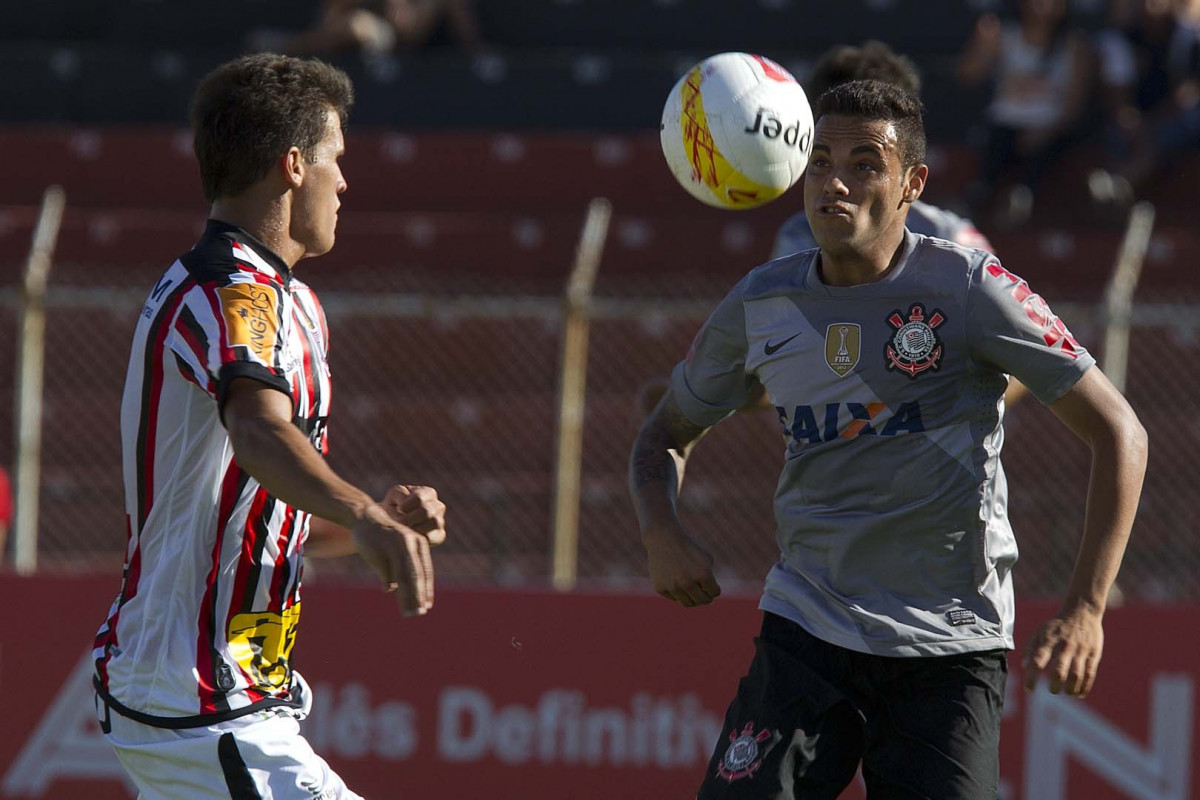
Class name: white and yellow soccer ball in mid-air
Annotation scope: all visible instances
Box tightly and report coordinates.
[661,53,812,209]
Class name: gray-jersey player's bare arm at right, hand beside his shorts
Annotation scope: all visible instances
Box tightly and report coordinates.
[1025,367,1147,697]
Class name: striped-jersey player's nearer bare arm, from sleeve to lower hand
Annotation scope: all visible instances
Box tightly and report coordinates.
[224,378,433,614]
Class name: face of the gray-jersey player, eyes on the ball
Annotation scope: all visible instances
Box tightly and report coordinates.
[804,114,908,249]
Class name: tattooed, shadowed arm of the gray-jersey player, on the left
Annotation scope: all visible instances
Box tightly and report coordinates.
[629,390,721,608]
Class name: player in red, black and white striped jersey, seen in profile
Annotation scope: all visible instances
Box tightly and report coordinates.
[94,54,445,800]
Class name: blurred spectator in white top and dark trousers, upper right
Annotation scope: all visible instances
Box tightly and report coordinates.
[959,0,1092,224]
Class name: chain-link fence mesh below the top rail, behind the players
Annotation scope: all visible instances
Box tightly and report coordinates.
[0,284,1200,601]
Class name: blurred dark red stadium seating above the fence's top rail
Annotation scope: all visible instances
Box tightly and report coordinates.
[0,128,1200,299]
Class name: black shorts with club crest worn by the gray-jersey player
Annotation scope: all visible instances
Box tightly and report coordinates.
[697,613,1008,800]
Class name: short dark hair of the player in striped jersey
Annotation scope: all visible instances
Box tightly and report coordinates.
[191,53,354,203]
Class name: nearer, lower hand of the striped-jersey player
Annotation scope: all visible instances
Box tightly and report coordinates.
[350,505,433,616]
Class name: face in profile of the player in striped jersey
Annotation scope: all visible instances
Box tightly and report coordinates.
[292,109,346,255]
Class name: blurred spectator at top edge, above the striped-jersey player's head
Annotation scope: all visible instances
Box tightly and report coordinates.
[250,0,480,55]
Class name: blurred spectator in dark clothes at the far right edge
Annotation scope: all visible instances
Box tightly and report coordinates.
[1088,0,1200,205]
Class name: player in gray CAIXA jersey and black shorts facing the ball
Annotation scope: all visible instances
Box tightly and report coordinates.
[630,80,1146,800]
